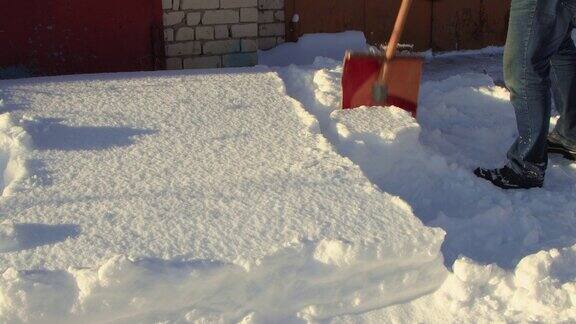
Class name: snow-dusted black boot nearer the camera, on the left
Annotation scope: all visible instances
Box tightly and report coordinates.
[474,166,544,189]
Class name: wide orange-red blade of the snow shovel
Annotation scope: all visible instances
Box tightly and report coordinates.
[342,53,422,117]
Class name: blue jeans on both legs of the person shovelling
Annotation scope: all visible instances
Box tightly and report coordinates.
[504,0,576,178]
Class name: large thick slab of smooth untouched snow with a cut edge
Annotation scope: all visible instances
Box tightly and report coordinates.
[0,68,446,323]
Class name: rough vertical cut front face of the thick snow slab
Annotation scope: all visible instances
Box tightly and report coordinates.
[0,241,445,323]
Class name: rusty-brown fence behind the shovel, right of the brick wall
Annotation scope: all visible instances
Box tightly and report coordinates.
[285,0,511,51]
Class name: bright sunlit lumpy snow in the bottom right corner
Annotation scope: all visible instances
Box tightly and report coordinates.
[331,245,576,324]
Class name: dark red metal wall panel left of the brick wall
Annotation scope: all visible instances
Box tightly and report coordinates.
[0,0,162,75]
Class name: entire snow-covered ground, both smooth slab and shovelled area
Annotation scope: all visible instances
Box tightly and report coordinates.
[0,32,576,323]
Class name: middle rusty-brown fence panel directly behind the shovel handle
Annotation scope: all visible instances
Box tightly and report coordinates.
[365,0,432,50]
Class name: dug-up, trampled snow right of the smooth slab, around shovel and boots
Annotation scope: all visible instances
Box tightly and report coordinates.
[281,55,576,323]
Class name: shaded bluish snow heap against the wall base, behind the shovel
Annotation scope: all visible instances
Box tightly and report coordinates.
[258,31,367,66]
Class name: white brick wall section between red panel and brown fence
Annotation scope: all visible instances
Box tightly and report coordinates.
[158,0,285,69]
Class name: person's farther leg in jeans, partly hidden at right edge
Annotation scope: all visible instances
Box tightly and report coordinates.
[550,6,576,151]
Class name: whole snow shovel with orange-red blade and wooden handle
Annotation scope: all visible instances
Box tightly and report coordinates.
[342,0,422,117]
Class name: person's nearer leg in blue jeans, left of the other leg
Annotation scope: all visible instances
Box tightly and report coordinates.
[504,0,572,179]
